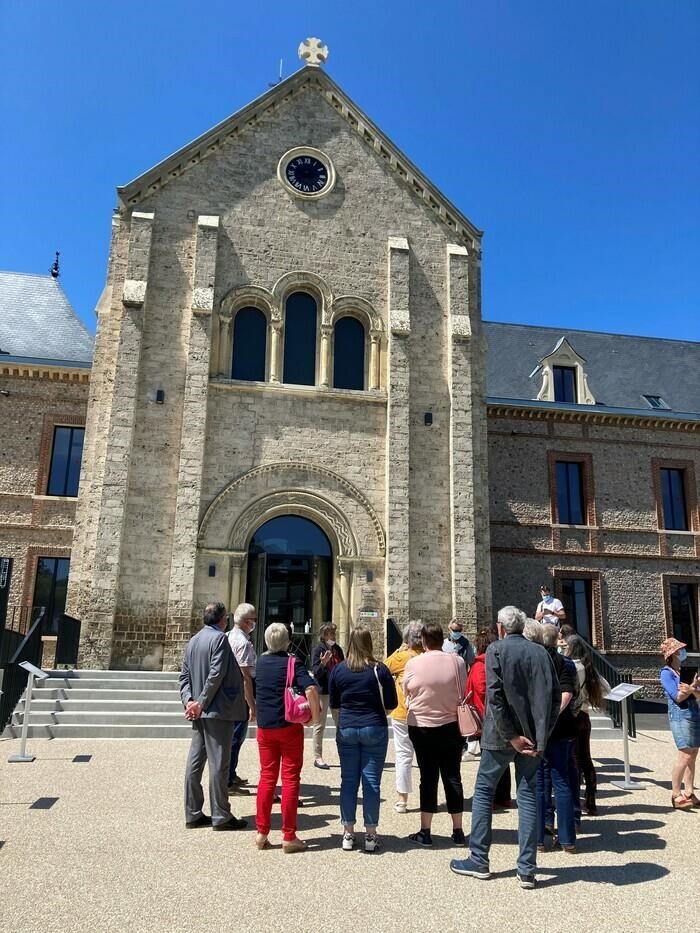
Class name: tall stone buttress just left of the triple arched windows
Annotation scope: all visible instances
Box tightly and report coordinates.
[163,216,219,670]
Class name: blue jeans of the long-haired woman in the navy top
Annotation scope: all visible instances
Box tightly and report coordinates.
[336,726,389,826]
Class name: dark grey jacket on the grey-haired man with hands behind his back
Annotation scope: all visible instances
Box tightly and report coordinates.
[481,635,561,752]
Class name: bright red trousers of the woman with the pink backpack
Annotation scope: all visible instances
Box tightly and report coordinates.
[255,723,304,842]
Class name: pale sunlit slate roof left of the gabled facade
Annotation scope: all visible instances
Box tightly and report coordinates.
[0,272,94,363]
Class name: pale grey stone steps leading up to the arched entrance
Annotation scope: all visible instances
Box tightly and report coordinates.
[4,670,622,741]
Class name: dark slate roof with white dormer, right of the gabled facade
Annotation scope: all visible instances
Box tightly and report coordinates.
[484,321,700,414]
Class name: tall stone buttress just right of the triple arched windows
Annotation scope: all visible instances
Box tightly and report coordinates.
[385,237,411,627]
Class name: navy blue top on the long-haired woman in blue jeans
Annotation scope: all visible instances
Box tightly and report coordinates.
[328,661,399,729]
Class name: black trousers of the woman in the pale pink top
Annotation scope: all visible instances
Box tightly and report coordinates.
[408,722,464,813]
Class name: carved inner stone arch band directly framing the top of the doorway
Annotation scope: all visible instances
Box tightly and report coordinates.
[229,489,357,557]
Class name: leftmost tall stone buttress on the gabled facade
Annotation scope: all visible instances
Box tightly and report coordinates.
[79,211,154,669]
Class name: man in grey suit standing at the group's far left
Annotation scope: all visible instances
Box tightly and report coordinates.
[180,603,248,830]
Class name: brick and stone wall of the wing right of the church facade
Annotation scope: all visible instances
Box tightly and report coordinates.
[488,408,700,683]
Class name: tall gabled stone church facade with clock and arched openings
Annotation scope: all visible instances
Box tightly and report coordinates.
[68,67,491,667]
